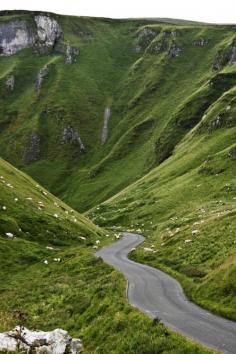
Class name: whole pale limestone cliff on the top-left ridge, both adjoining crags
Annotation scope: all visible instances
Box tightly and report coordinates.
[0,15,61,56]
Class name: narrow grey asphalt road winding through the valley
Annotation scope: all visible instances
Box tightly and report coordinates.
[96,233,236,354]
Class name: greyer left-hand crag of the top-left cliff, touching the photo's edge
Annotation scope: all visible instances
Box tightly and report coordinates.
[0,21,35,55]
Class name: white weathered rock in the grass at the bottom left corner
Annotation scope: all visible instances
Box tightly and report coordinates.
[0,326,83,354]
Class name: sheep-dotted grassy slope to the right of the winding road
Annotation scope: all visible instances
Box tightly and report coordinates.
[90,92,236,320]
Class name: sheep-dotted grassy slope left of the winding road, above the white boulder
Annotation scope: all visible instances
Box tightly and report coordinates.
[0,160,210,354]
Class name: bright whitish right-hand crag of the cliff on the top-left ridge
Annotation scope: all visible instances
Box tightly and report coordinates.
[34,15,61,47]
